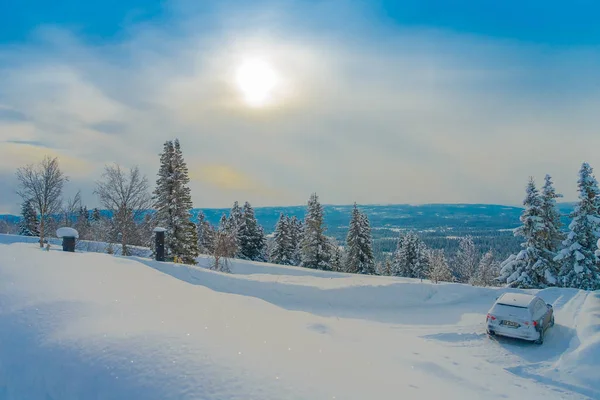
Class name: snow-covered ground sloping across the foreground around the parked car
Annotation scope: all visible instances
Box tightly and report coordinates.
[0,235,600,400]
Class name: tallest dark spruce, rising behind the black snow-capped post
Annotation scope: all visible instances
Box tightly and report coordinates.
[154,139,198,264]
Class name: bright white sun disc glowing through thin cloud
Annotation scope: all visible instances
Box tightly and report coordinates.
[236,59,278,107]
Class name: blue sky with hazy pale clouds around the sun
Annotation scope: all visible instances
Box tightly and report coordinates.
[0,0,600,212]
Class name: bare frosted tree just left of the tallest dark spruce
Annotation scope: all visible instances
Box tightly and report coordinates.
[94,164,152,256]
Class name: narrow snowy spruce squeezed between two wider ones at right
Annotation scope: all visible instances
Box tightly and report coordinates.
[540,175,565,286]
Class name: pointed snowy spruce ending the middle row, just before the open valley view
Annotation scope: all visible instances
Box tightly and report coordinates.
[344,203,375,274]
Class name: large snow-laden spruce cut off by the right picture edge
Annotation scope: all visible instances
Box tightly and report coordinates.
[555,163,600,290]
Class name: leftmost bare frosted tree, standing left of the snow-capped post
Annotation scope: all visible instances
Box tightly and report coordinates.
[17,156,69,248]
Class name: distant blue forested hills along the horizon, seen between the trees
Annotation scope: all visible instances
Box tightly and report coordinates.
[0,203,574,261]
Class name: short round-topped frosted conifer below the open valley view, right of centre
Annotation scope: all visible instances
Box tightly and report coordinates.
[392,232,429,279]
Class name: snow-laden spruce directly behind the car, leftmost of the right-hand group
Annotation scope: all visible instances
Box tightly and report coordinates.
[499,178,551,288]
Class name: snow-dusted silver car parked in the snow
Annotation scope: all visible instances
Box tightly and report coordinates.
[486,293,554,344]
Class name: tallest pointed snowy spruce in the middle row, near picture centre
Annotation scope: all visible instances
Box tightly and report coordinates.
[300,193,330,270]
